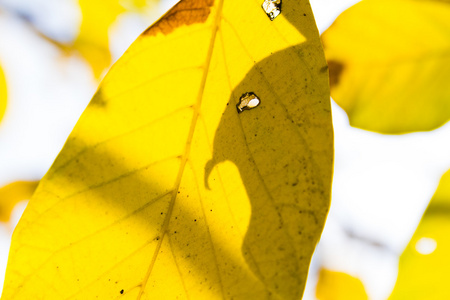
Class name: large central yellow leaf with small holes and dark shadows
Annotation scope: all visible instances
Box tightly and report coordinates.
[2,0,333,300]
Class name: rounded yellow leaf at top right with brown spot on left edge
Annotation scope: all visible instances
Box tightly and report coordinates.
[322,0,450,134]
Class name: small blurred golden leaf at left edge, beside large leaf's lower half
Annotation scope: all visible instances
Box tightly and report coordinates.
[0,181,39,223]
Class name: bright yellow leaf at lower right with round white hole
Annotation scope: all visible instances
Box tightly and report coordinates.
[389,171,450,300]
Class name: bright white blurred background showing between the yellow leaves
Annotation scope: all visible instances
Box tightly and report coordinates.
[0,0,450,300]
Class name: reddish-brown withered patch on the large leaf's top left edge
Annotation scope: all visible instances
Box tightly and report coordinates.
[143,0,214,36]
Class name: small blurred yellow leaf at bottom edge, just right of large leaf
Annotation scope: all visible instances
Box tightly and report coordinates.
[316,269,368,300]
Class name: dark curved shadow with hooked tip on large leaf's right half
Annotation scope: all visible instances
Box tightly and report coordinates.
[204,2,333,299]
